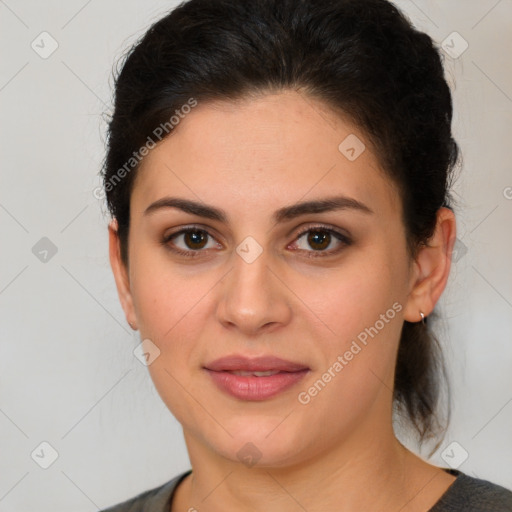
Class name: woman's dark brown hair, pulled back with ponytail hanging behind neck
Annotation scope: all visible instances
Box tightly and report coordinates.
[102,0,459,448]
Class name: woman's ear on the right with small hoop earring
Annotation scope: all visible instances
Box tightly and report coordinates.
[404,207,456,322]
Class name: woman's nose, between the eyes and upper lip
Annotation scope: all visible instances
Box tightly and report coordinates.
[216,243,292,336]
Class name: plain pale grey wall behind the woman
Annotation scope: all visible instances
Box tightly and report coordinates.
[0,0,512,512]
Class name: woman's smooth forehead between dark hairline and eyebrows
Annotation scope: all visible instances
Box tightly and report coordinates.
[132,91,398,220]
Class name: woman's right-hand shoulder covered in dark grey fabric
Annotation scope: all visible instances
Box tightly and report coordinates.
[430,471,512,512]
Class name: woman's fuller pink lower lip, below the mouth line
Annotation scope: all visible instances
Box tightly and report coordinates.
[206,369,309,400]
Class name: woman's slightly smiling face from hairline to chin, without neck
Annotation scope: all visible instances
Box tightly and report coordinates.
[116,91,419,466]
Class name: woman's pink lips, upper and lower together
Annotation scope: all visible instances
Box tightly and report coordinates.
[205,356,309,400]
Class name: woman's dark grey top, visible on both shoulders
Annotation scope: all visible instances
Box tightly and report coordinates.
[100,468,512,512]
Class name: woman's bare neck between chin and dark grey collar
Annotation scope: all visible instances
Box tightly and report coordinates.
[176,412,453,512]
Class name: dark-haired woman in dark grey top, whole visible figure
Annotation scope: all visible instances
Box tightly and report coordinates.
[99,0,512,512]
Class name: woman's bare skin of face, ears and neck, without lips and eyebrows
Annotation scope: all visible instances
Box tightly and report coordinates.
[109,91,456,512]
